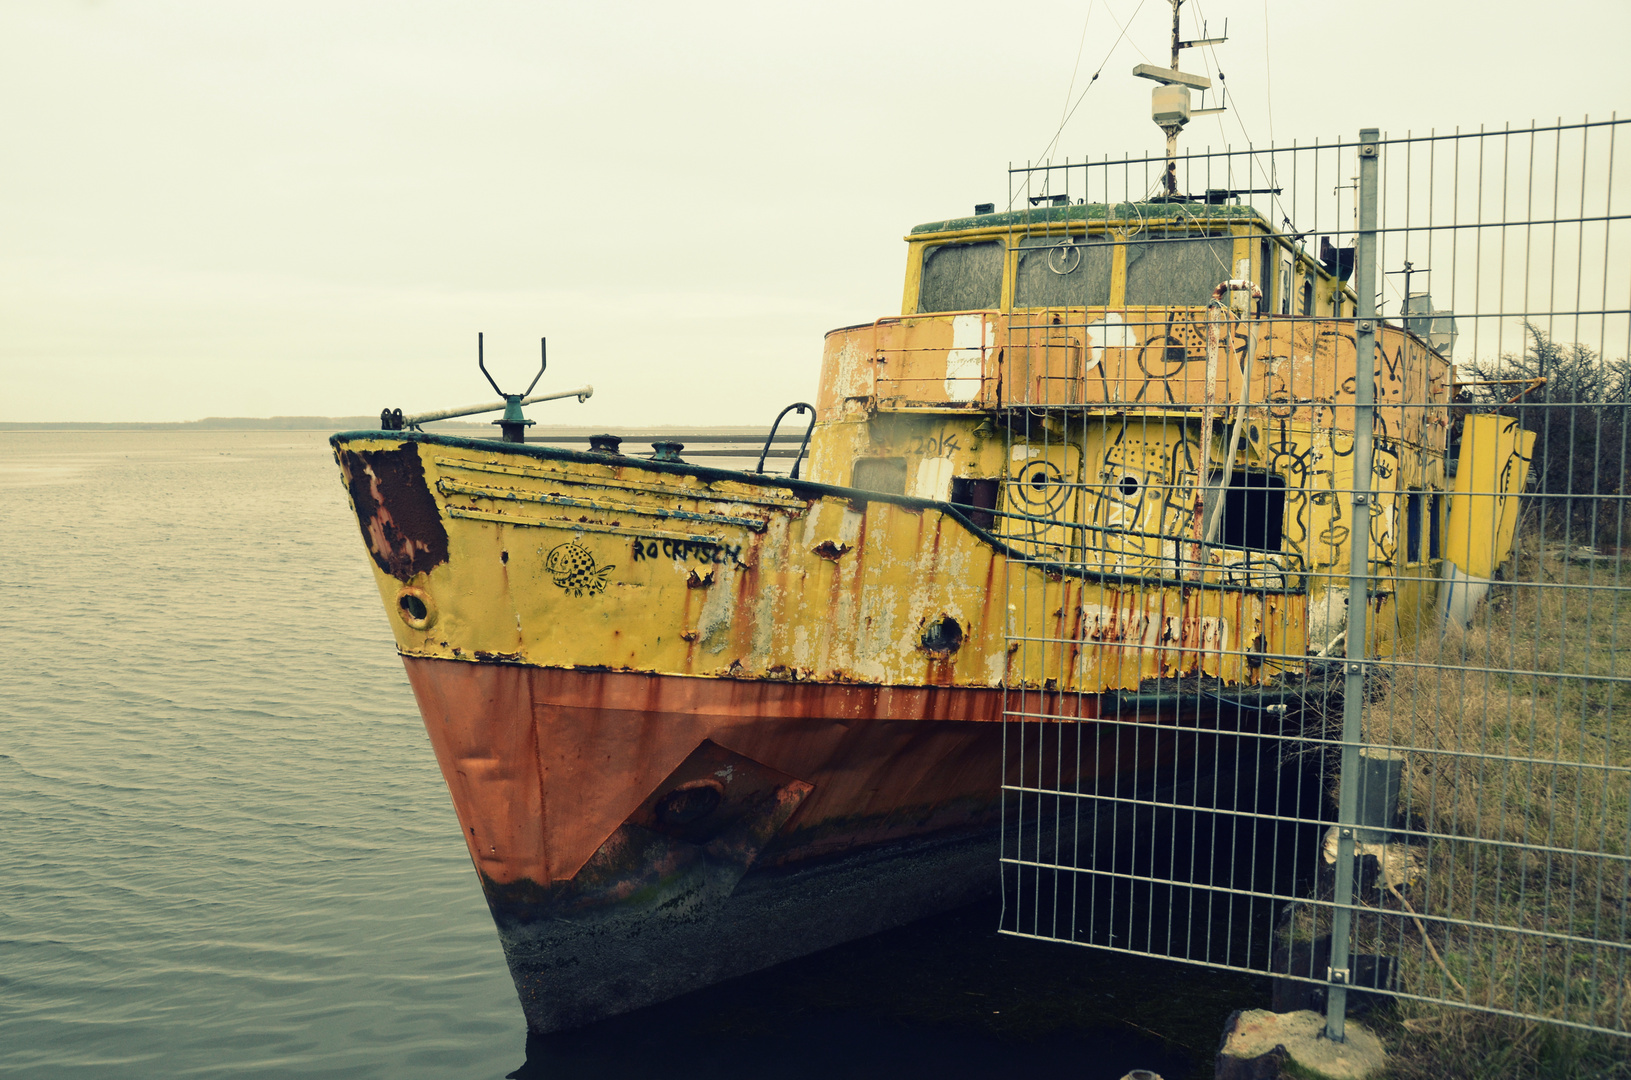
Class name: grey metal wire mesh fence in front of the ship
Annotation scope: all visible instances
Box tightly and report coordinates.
[997,121,1631,1036]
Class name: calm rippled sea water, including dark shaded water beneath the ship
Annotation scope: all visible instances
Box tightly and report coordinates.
[0,431,1258,1080]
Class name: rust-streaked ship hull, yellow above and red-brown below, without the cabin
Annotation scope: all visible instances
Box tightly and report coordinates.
[333,432,1302,1031]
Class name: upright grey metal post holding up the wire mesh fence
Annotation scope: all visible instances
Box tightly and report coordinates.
[1326,127,1380,1042]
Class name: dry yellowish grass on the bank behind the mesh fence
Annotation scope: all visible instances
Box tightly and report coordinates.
[1355,553,1631,1078]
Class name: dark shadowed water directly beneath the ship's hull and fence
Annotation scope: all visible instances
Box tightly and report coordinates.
[509,904,1246,1080]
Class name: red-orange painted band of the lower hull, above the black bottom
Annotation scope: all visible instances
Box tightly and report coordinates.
[403,657,1001,884]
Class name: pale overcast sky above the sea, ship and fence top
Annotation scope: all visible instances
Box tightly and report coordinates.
[0,0,1631,426]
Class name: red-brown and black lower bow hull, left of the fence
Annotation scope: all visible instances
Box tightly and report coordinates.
[404,657,1173,1031]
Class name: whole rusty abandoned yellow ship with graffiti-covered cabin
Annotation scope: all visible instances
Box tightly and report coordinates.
[333,171,1523,1033]
